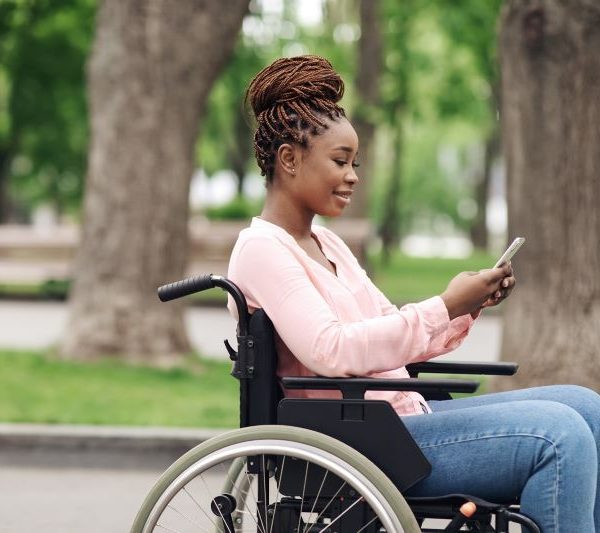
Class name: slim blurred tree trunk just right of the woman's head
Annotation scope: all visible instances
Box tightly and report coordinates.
[346,0,383,218]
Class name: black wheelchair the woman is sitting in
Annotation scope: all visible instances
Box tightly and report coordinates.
[131,275,540,533]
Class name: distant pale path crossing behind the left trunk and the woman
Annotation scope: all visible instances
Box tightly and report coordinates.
[0,301,502,361]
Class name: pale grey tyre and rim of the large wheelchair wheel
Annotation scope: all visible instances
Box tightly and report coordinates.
[131,426,420,533]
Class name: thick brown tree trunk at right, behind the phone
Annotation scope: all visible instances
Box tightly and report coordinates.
[500,0,600,389]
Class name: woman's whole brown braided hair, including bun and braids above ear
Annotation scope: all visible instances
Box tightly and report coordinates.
[246,55,346,182]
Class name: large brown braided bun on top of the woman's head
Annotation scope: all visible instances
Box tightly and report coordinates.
[246,55,344,118]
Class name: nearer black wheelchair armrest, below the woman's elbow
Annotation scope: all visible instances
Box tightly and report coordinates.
[281,376,479,399]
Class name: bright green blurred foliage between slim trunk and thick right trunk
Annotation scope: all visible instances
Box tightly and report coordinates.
[375,0,499,251]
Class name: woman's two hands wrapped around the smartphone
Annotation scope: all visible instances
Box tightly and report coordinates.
[441,263,515,320]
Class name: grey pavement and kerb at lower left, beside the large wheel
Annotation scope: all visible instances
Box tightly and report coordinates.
[0,424,220,533]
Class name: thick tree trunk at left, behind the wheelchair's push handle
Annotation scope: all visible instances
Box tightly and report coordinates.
[61,0,248,364]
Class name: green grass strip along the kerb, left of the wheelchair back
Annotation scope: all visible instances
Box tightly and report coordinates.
[0,351,239,427]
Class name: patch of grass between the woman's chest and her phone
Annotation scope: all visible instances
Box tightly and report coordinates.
[370,252,495,304]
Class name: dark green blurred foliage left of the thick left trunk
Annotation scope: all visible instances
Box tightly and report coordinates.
[0,0,95,217]
